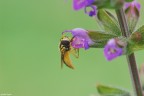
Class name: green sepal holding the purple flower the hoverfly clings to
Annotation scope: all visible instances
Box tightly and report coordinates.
[88,31,117,48]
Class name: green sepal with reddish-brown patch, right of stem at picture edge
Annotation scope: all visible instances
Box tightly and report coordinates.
[127,25,144,54]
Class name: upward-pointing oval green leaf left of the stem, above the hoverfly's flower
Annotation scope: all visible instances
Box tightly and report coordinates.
[97,9,121,36]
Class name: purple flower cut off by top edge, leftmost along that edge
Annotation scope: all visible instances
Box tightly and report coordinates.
[73,0,94,10]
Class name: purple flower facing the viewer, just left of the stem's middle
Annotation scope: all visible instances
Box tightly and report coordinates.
[104,39,123,61]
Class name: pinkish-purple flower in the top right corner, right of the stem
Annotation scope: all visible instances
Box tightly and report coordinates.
[124,0,141,16]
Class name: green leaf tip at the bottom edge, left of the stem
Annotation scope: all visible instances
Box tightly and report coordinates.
[97,85,131,96]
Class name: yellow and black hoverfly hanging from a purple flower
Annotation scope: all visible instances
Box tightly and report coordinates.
[59,36,79,69]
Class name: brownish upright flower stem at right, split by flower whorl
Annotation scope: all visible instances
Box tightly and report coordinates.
[116,9,142,96]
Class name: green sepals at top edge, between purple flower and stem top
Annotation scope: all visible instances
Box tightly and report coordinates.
[93,0,124,9]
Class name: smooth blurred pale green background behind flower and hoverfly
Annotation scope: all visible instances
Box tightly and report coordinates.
[0,0,144,96]
